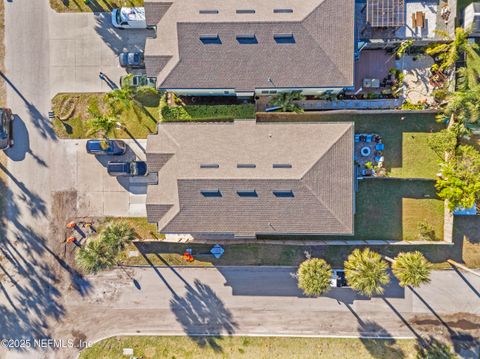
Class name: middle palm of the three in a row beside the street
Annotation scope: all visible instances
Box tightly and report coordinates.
[344,248,390,297]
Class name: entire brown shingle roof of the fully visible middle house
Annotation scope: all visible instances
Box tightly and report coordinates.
[147,120,354,237]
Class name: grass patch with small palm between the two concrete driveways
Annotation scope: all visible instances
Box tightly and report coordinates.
[52,93,160,138]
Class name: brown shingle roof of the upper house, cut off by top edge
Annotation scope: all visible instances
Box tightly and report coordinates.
[145,0,355,91]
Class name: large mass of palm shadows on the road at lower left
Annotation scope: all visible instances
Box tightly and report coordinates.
[0,179,89,351]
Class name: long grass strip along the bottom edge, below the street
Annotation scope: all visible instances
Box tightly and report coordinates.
[80,336,417,359]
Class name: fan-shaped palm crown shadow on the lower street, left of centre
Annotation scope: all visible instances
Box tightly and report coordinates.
[170,279,237,352]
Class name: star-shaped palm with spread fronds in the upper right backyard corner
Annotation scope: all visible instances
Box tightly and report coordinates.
[425,27,478,71]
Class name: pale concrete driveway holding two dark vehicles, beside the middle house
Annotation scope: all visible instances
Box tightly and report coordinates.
[51,140,152,217]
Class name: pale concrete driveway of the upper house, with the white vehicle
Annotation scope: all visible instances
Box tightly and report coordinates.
[48,13,153,97]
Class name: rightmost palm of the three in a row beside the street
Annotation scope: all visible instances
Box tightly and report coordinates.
[385,251,432,288]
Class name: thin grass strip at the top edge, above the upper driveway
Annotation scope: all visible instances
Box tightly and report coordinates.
[50,0,143,12]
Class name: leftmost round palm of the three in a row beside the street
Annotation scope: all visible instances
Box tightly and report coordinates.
[297,258,332,296]
